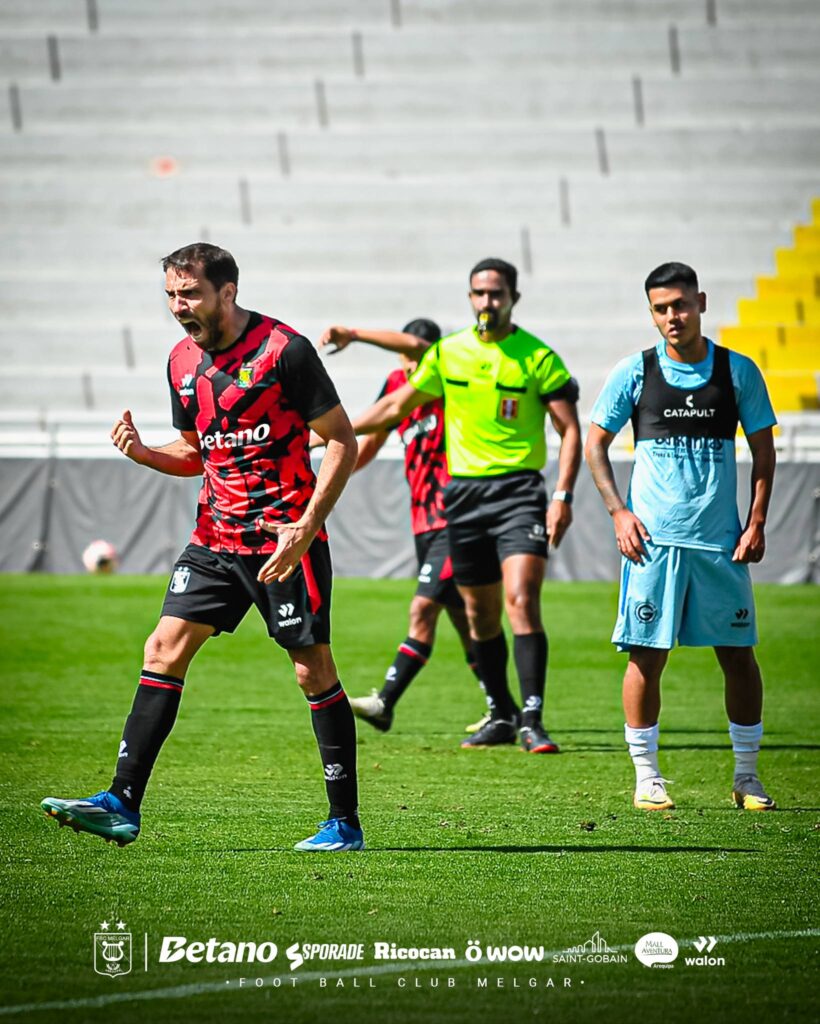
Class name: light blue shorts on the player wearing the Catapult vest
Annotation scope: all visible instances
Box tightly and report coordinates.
[612,544,758,650]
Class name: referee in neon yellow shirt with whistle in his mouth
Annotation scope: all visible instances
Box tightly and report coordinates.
[356,259,581,754]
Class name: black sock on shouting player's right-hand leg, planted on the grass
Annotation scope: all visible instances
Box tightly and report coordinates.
[307,682,359,828]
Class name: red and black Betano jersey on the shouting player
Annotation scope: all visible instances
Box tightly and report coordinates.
[168,313,339,554]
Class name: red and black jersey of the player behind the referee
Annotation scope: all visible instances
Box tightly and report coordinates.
[379,370,449,535]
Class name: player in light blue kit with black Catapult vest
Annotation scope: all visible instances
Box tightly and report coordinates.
[586,263,776,811]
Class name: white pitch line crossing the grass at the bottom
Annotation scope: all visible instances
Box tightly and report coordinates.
[0,928,820,1017]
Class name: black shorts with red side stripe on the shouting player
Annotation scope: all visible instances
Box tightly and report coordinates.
[162,540,333,649]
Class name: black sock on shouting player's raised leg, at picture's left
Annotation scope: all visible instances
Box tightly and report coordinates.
[111,669,184,811]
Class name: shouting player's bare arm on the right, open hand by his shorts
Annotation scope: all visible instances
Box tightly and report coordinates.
[257,406,358,583]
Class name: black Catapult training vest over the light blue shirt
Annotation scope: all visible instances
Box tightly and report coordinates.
[632,345,739,442]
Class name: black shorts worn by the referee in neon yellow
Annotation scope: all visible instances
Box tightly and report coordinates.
[443,472,547,587]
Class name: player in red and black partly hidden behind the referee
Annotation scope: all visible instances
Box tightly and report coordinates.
[318,318,499,732]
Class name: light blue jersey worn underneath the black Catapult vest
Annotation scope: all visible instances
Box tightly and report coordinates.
[591,339,777,551]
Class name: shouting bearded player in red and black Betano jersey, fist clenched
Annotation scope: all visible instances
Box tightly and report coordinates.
[41,243,364,852]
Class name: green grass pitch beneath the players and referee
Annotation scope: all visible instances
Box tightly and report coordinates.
[0,577,820,1024]
